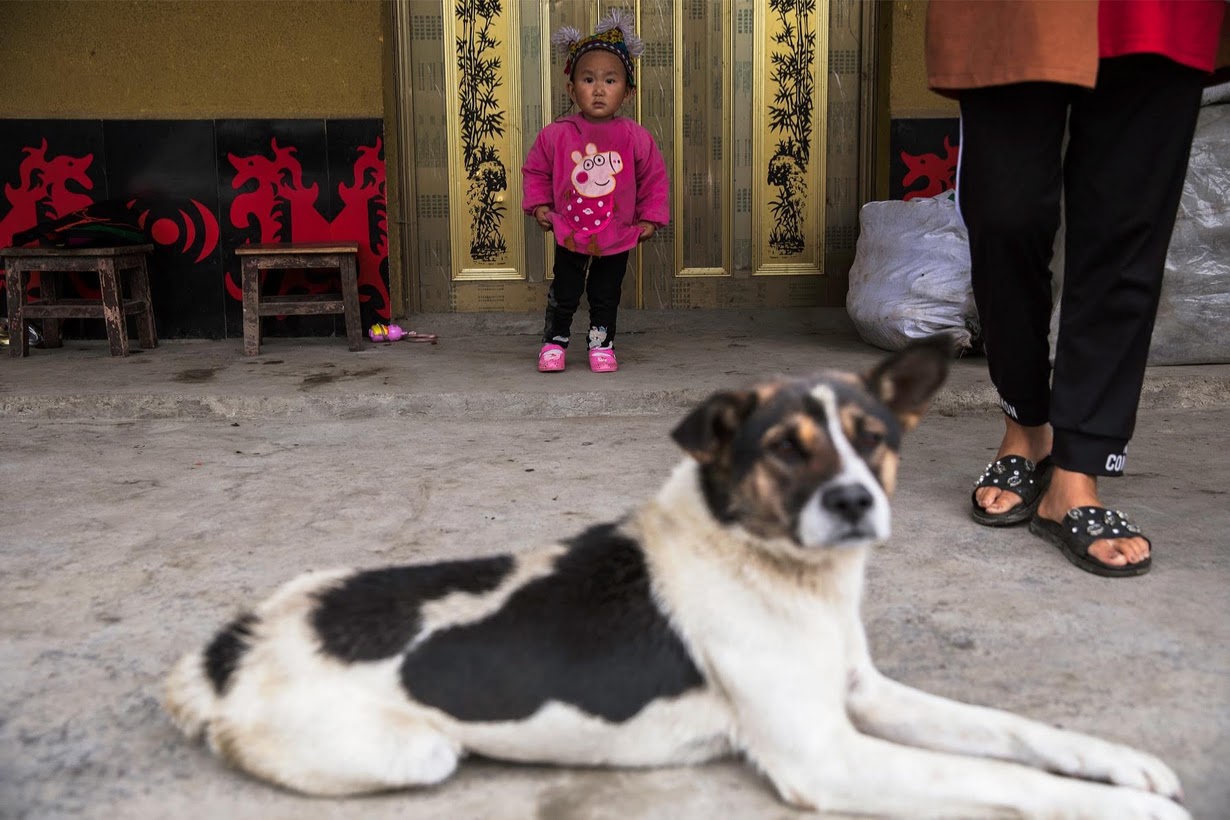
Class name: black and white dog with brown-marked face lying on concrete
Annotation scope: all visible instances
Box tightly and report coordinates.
[166,339,1188,820]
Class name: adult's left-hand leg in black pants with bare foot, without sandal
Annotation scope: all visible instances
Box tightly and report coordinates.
[957,82,1073,515]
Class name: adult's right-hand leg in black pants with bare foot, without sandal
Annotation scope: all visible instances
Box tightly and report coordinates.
[1038,54,1203,567]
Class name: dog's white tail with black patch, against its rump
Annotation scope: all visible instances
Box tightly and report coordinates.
[164,613,256,740]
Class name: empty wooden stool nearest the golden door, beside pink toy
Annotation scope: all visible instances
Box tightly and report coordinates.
[235,242,363,355]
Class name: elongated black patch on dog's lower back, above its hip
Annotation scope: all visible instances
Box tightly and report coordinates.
[312,556,513,660]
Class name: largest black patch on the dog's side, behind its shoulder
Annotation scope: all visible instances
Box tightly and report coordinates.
[401,524,704,722]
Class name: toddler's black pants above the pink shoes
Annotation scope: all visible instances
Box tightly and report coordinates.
[542,245,629,348]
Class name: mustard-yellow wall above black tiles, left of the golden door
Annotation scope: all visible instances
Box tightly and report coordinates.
[0,0,384,119]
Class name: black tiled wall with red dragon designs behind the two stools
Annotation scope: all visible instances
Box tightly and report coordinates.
[0,119,390,338]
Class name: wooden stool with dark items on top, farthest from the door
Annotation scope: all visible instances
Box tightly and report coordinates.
[0,245,157,357]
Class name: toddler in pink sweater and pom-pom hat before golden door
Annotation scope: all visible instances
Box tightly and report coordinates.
[522,11,670,373]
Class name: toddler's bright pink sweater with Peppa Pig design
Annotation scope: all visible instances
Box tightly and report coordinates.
[522,114,670,256]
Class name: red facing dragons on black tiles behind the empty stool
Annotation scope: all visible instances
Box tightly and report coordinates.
[226,136,390,320]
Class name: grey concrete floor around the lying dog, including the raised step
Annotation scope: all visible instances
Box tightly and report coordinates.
[0,313,1230,820]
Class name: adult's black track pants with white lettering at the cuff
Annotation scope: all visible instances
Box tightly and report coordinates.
[957,55,1205,476]
